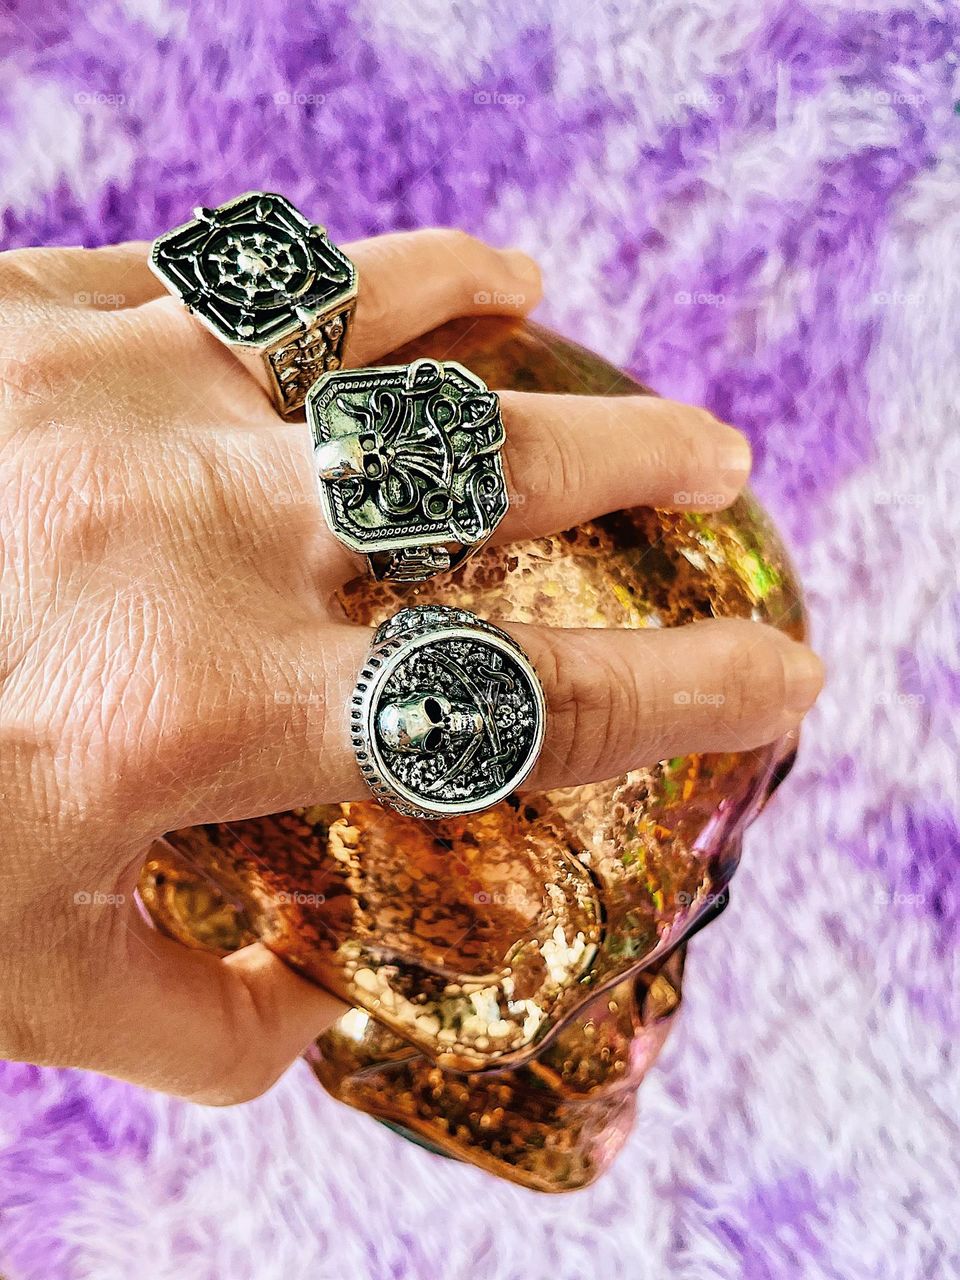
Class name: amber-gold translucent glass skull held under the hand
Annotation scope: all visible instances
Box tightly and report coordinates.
[141,319,804,1190]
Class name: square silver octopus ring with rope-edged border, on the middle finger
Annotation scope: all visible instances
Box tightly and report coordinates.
[307,360,509,582]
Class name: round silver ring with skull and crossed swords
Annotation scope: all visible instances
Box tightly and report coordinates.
[351,604,547,818]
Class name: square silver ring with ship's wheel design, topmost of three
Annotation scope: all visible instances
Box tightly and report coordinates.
[150,191,357,413]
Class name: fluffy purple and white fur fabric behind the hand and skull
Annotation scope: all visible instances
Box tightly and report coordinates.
[0,0,960,1280]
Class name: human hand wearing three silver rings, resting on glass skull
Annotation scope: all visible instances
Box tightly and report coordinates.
[0,232,820,1102]
